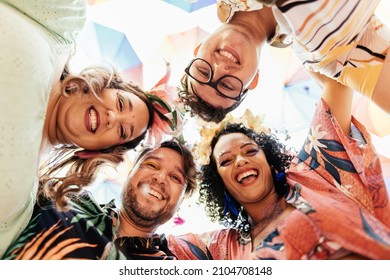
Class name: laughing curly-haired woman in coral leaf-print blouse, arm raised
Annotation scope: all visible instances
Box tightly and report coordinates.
[193,72,390,259]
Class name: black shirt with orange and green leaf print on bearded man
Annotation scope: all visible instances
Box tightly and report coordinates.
[3,192,195,260]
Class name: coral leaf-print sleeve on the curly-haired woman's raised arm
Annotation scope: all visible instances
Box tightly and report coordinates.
[292,99,390,226]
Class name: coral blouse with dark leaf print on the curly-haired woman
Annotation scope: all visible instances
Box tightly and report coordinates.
[170,100,390,259]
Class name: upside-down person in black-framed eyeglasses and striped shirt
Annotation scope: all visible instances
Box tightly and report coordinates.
[179,0,390,122]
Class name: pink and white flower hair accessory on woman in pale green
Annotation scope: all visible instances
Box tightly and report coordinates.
[147,63,184,144]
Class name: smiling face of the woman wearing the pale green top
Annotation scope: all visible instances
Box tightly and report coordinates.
[56,88,149,150]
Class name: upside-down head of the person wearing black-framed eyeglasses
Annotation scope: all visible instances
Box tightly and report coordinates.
[179,6,266,123]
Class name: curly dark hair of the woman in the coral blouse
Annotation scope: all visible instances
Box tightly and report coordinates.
[199,123,293,228]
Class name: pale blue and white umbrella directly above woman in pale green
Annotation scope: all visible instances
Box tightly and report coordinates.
[72,22,143,86]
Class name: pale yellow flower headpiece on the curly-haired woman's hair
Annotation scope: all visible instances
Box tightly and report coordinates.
[192,109,271,165]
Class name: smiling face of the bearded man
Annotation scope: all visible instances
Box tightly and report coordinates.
[122,148,186,228]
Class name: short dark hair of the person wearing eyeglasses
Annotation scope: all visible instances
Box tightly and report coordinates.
[178,74,244,123]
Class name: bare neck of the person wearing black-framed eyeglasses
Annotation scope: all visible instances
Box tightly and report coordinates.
[228,7,277,45]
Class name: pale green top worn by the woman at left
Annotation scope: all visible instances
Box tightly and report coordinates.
[0,0,85,256]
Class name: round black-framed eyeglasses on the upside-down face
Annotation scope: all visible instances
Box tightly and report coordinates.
[184,58,246,101]
